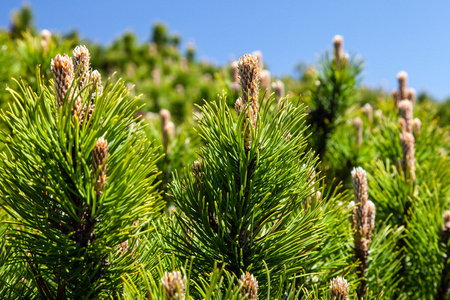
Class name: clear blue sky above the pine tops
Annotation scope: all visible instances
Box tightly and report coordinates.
[0,0,450,100]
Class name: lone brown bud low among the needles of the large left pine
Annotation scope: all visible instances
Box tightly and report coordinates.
[92,137,108,195]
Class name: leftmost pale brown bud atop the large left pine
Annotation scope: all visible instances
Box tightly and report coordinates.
[51,54,74,111]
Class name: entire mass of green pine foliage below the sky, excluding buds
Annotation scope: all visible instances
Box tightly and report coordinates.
[0,7,450,299]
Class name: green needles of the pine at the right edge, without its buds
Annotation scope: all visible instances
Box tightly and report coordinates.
[369,130,450,299]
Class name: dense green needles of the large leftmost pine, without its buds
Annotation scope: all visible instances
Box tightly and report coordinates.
[0,64,161,298]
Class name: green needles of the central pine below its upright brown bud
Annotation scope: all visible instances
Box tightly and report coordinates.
[171,96,356,295]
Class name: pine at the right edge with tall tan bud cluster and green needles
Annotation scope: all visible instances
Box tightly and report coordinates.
[369,72,450,299]
